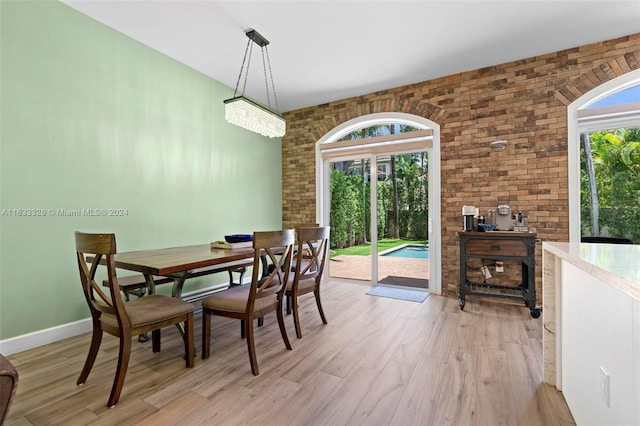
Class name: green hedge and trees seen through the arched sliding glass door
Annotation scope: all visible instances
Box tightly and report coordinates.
[330,124,429,249]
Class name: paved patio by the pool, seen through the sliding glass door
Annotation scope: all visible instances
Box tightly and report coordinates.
[329,255,429,289]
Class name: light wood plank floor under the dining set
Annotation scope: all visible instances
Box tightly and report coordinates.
[6,280,574,426]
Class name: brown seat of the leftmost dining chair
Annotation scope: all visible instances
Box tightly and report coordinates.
[100,294,193,327]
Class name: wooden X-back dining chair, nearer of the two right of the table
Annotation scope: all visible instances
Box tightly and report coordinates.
[202,229,295,376]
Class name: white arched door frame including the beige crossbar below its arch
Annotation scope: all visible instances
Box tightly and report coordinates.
[316,112,442,294]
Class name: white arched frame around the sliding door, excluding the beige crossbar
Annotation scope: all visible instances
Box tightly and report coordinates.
[315,112,442,294]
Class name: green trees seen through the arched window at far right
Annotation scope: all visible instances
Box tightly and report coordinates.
[580,128,640,244]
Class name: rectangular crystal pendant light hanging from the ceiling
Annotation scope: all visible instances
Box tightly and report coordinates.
[224,30,286,138]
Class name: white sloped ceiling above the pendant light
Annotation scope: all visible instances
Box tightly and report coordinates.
[63,0,640,112]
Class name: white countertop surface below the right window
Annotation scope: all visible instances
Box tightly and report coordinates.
[542,241,640,300]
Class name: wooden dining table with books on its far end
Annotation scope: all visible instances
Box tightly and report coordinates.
[115,244,266,298]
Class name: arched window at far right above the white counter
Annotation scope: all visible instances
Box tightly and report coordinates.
[578,84,640,244]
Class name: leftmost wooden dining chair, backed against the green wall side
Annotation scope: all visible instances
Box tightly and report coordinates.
[75,232,194,407]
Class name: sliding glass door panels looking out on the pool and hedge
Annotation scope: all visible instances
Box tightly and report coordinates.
[328,152,429,289]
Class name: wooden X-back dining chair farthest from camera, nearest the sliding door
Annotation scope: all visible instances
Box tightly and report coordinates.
[285,226,330,338]
